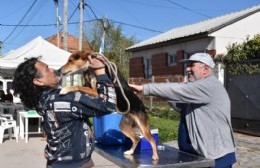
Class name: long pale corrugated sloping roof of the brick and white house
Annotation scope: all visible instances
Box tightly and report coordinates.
[126,4,260,51]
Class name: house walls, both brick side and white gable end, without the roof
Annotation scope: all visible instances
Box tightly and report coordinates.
[130,12,260,83]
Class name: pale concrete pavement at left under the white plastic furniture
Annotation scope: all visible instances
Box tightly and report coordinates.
[0,135,118,168]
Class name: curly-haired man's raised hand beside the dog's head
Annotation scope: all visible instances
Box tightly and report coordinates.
[88,55,106,75]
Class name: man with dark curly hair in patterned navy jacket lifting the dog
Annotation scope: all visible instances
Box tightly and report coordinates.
[13,56,116,168]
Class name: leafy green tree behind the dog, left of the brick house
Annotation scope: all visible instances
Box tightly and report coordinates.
[84,20,136,79]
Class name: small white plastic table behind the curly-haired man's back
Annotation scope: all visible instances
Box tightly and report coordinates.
[19,111,42,143]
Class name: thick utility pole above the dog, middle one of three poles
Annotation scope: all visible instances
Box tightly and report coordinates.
[62,0,68,51]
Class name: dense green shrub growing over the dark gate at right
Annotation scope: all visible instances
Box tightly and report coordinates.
[221,34,260,75]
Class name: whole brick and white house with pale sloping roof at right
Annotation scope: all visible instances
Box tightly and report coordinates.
[126,5,260,84]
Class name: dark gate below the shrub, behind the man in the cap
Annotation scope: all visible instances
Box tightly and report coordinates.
[225,60,260,136]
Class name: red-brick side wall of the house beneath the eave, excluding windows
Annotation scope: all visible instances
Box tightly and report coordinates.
[129,38,215,84]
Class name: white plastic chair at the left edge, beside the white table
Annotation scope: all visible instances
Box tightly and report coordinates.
[0,115,18,144]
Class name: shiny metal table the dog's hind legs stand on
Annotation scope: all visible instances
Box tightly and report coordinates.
[95,143,215,168]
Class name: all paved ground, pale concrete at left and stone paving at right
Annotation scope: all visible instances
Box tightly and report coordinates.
[0,133,260,168]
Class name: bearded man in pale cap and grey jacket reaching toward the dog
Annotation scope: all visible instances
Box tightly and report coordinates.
[130,53,236,168]
